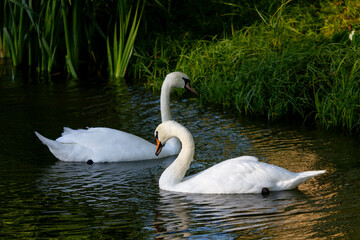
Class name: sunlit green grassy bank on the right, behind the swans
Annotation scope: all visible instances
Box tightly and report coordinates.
[135,2,360,133]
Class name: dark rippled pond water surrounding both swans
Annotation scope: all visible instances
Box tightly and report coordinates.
[0,61,360,239]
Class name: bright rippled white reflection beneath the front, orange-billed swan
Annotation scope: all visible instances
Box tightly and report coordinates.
[154,190,306,239]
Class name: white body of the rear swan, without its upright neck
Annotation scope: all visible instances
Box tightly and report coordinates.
[38,128,176,162]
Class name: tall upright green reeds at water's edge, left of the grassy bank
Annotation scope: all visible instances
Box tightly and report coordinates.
[0,0,144,78]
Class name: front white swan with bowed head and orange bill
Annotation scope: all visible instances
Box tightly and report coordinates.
[154,121,325,194]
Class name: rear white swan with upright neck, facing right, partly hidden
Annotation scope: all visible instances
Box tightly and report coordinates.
[35,72,197,163]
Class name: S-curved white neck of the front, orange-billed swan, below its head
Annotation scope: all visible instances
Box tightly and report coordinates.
[159,129,195,190]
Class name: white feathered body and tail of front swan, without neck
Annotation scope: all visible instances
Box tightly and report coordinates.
[174,157,323,193]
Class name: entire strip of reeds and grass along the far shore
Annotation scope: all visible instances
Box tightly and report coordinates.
[0,0,360,134]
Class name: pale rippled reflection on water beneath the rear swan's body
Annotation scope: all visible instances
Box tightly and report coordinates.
[37,156,175,207]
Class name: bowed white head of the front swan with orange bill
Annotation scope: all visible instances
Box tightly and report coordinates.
[154,120,193,156]
